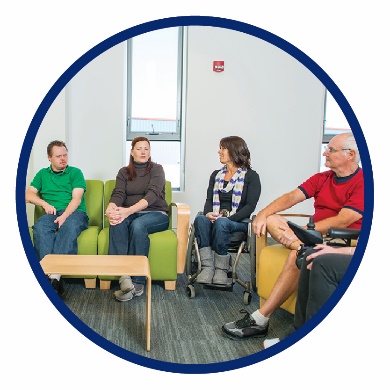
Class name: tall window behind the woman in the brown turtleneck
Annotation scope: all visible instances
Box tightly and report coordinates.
[126,27,184,190]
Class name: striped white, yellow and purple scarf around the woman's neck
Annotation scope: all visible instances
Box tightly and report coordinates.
[213,165,247,216]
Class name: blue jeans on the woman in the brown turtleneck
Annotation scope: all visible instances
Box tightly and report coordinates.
[108,211,169,284]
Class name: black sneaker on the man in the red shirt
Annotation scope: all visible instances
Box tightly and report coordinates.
[222,309,268,340]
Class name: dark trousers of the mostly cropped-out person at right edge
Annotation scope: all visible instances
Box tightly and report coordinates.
[294,249,352,329]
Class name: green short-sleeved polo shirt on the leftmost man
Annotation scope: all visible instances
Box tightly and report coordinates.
[30,165,87,212]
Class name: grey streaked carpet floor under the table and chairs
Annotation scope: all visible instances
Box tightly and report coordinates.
[63,254,293,364]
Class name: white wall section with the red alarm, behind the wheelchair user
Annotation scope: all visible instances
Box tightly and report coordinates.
[175,27,325,219]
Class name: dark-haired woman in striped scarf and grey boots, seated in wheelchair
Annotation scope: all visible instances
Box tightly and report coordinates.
[194,136,261,284]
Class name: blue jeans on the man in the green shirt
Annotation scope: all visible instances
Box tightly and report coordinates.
[33,210,88,261]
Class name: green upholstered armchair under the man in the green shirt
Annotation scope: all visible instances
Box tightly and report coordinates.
[30,180,104,288]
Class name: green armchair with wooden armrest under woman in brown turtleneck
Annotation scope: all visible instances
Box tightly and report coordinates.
[98,180,190,290]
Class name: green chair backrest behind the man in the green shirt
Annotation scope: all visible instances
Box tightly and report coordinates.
[34,180,104,229]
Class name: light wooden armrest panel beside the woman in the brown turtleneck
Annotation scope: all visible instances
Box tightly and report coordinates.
[172,202,191,274]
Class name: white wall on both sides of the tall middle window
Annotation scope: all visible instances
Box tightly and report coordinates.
[29,27,325,225]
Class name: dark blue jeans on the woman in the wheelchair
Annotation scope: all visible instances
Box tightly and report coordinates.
[194,215,248,256]
